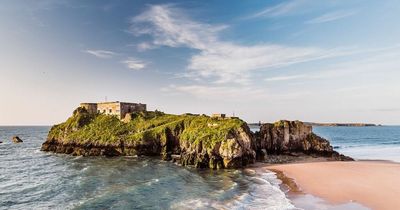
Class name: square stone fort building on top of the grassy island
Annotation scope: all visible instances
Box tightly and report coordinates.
[80,101,146,119]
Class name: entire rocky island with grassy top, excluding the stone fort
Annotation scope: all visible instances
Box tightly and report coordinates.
[42,108,352,168]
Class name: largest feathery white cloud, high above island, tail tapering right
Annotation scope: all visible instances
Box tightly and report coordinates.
[130,5,344,84]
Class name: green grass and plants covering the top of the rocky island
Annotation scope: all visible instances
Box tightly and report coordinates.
[48,108,245,148]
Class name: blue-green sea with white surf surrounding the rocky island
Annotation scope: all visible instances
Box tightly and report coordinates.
[0,126,400,210]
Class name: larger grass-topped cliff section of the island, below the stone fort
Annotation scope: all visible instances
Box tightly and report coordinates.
[42,108,255,168]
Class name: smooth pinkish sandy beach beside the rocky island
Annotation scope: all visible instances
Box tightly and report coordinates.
[266,161,400,210]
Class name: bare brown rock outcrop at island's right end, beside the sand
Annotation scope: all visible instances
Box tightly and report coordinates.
[257,120,352,160]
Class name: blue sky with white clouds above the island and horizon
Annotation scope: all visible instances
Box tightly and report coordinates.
[0,0,400,125]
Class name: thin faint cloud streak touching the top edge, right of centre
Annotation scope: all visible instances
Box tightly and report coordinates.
[247,0,304,19]
